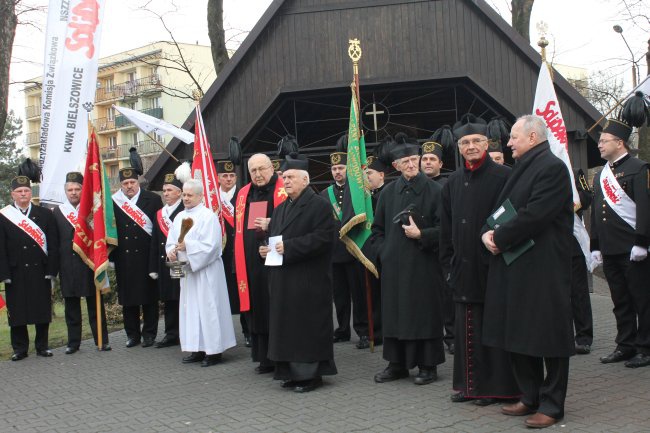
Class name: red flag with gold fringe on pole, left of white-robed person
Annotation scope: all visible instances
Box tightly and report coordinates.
[72,131,117,292]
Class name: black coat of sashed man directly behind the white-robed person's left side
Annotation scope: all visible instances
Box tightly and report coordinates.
[149,200,185,301]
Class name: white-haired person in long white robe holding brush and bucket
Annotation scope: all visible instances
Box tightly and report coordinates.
[166,179,236,367]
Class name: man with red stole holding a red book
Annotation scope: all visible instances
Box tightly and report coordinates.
[235,153,287,374]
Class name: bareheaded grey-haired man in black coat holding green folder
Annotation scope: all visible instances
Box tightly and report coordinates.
[482,115,575,428]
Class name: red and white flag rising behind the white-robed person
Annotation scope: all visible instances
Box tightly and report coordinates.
[192,104,234,228]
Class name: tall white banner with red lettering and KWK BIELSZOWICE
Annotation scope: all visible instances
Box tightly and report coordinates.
[39,0,106,204]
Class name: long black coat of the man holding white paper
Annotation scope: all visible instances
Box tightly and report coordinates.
[268,187,336,362]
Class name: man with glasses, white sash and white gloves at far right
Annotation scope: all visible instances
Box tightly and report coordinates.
[591,119,650,368]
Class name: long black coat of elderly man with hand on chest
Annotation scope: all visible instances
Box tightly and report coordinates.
[371,173,443,340]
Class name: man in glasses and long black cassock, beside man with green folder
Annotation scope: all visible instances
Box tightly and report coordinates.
[440,114,520,406]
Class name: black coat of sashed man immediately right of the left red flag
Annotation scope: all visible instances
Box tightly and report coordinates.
[111,189,162,307]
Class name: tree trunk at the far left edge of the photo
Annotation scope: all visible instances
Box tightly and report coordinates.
[0,0,18,136]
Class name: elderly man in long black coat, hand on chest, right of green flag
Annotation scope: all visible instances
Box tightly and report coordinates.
[372,134,445,385]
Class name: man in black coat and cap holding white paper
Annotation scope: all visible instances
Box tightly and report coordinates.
[260,156,337,392]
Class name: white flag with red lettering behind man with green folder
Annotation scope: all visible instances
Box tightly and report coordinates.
[533,62,595,271]
